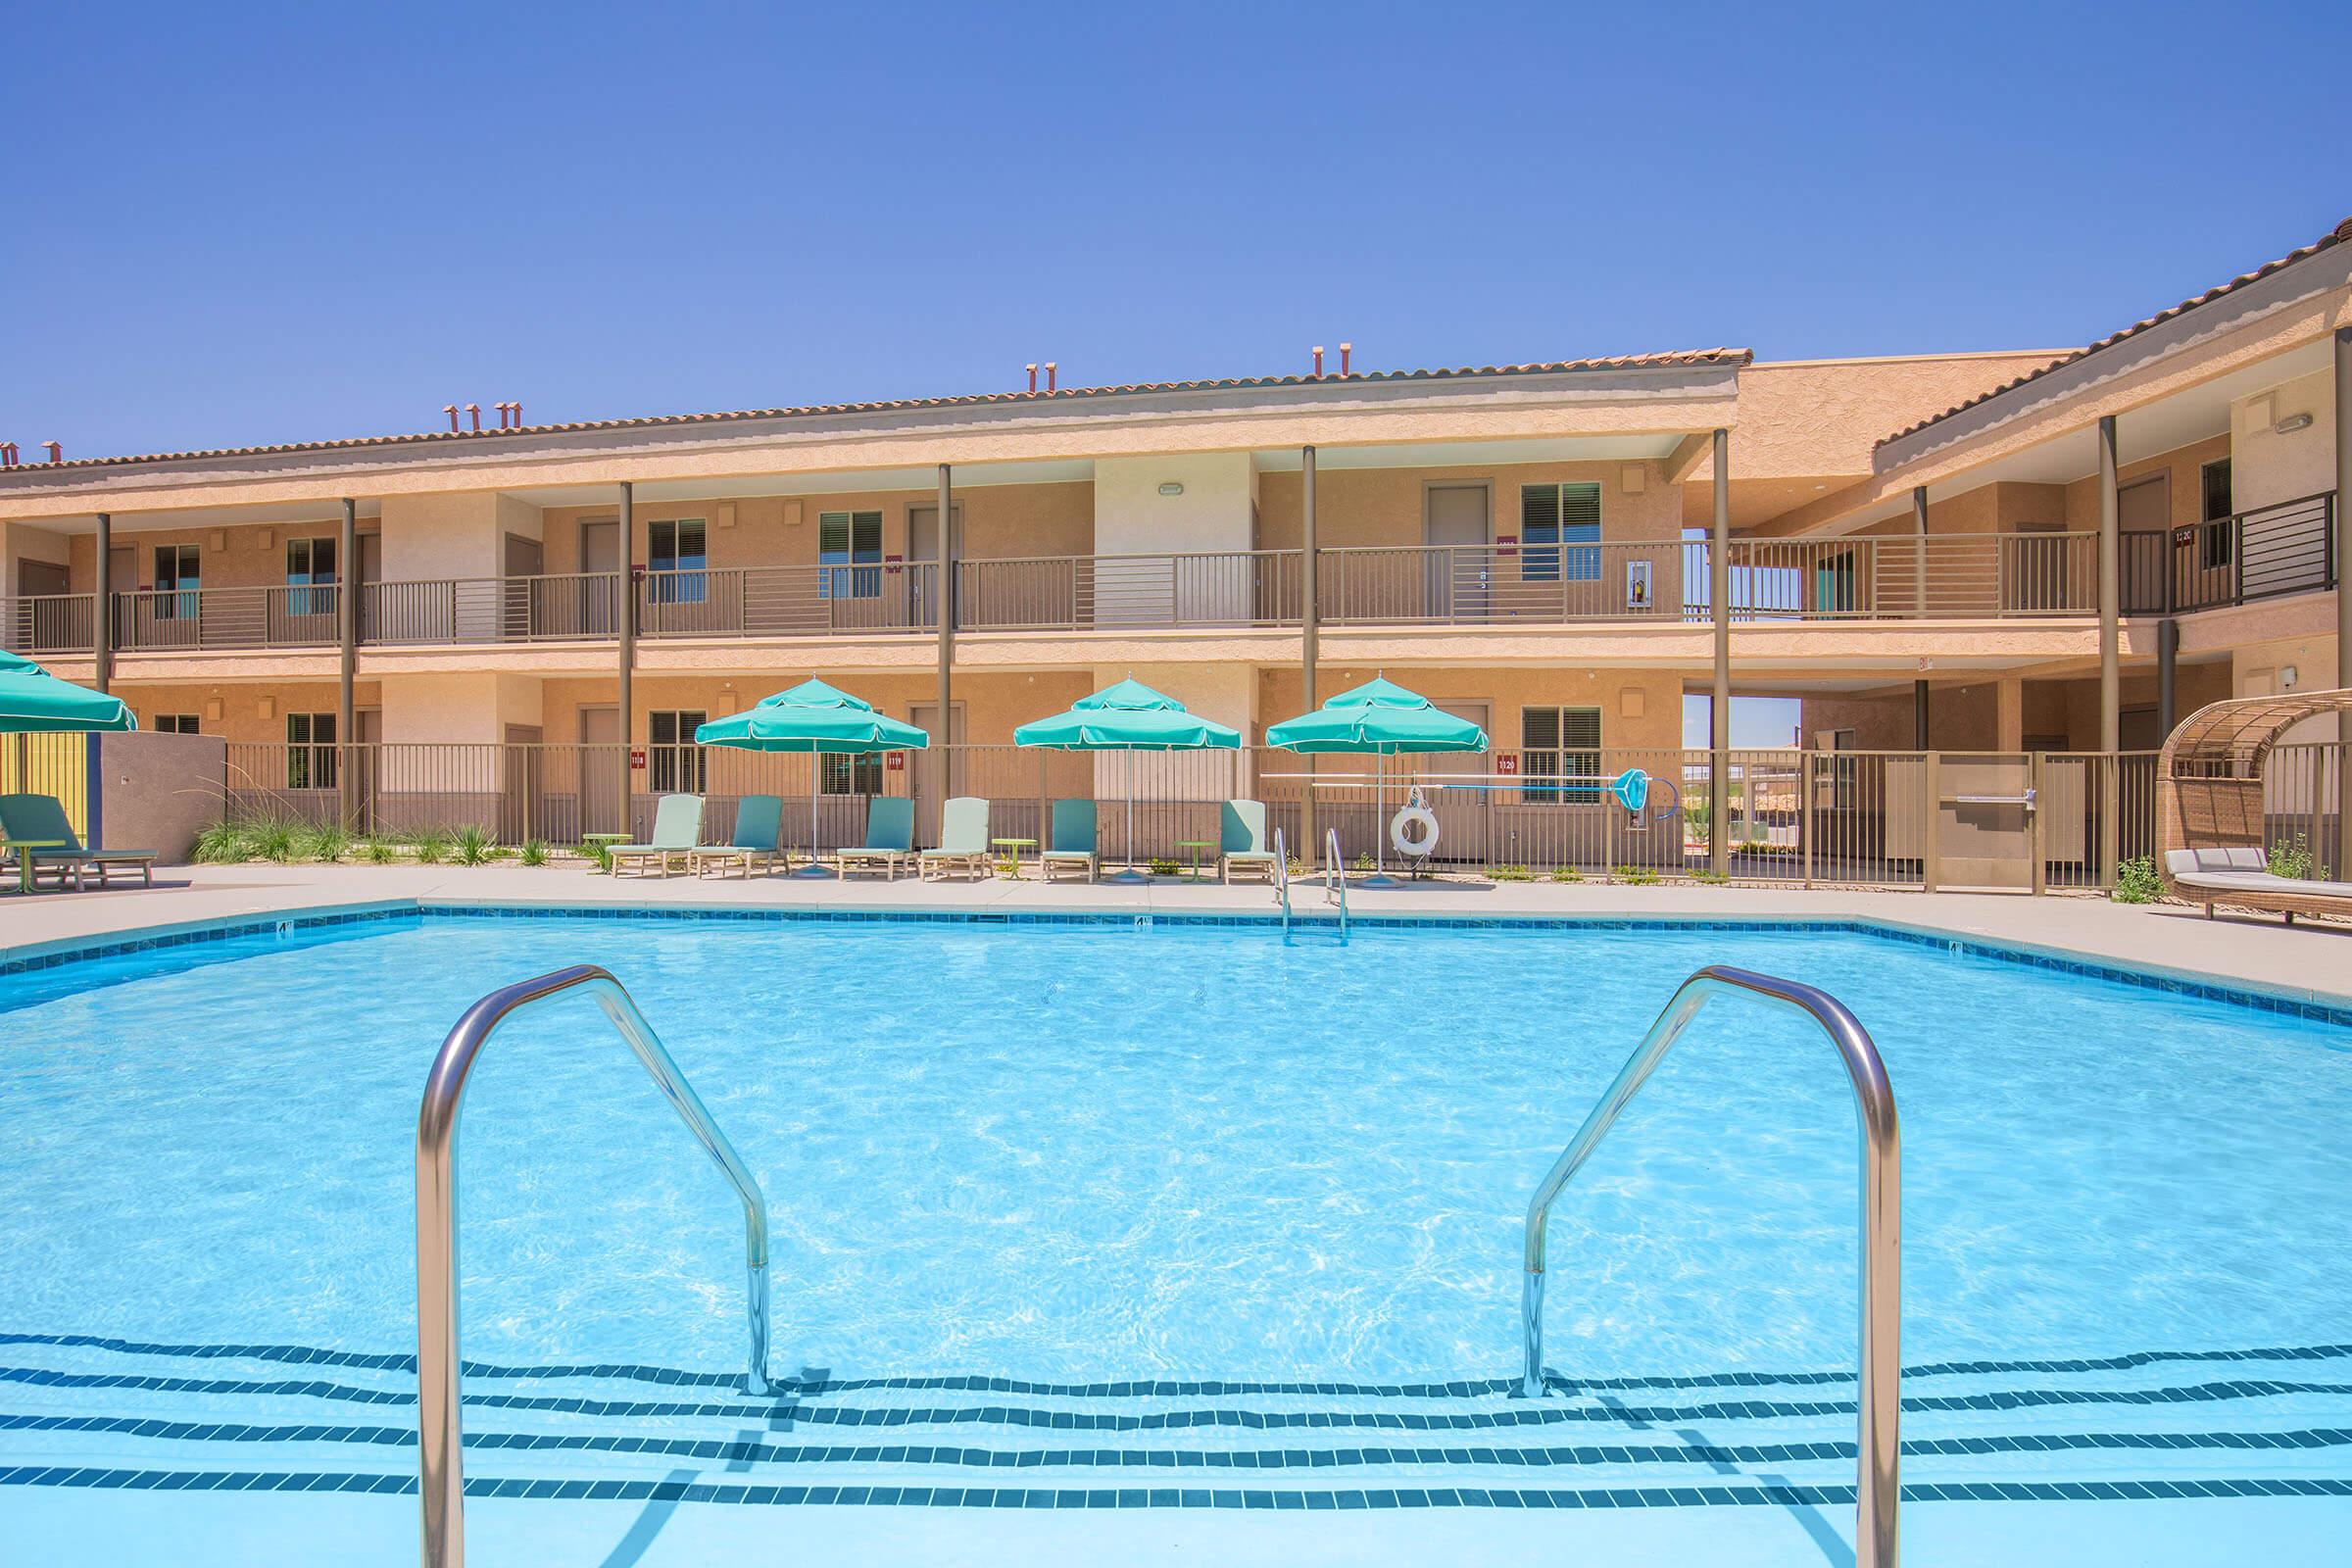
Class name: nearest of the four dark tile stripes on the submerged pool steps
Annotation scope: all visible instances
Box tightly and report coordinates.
[0,1464,2352,1511]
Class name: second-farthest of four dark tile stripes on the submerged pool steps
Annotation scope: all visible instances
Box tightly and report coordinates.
[0,1366,2352,1432]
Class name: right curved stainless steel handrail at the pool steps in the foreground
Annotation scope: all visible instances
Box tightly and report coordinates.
[1519,964,1903,1568]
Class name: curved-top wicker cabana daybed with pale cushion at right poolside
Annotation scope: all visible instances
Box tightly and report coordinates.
[2157,691,2352,924]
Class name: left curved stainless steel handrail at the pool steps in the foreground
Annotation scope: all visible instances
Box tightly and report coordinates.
[416,964,766,1568]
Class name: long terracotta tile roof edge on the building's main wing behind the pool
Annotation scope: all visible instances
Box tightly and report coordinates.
[0,348,1754,475]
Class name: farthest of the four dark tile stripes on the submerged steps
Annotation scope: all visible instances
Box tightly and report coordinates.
[14,1333,2352,1398]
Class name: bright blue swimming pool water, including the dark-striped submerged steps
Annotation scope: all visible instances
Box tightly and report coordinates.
[0,912,2352,1561]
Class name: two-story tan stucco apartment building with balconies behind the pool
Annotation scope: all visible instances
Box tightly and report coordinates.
[0,220,2352,888]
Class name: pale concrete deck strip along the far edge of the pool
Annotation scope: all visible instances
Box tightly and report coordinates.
[0,862,2352,1004]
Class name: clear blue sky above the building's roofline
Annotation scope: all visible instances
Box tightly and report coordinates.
[0,2,2352,456]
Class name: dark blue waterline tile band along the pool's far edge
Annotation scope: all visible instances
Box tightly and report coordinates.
[0,901,2352,1027]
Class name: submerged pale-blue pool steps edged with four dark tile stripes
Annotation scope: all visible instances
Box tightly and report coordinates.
[0,1336,2352,1507]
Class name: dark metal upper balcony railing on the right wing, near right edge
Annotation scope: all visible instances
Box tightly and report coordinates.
[2122,491,2335,615]
